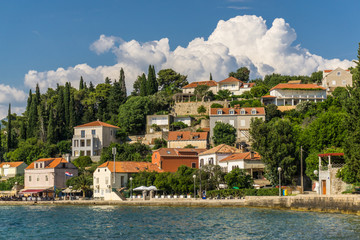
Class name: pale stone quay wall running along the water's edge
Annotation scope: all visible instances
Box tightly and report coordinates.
[0,195,360,215]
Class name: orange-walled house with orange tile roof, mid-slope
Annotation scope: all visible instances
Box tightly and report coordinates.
[151,148,206,172]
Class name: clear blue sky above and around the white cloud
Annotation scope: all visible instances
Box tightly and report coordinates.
[0,0,360,115]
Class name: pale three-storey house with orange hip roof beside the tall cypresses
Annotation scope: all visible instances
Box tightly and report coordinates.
[72,121,119,157]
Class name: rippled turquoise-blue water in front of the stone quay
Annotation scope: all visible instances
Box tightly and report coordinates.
[0,206,360,240]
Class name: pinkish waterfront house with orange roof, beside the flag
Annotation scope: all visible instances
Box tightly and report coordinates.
[24,158,78,190]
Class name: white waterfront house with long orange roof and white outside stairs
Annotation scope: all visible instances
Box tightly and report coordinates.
[93,161,162,200]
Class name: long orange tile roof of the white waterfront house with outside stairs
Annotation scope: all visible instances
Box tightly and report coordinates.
[98,161,163,173]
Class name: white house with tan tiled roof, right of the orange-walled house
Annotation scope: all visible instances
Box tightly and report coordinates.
[199,144,241,168]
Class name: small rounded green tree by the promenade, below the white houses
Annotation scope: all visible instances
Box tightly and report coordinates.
[225,168,253,189]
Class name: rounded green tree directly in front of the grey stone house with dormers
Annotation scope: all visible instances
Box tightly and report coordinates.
[213,122,236,146]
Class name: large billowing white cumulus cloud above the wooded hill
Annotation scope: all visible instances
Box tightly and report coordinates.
[25,15,353,94]
